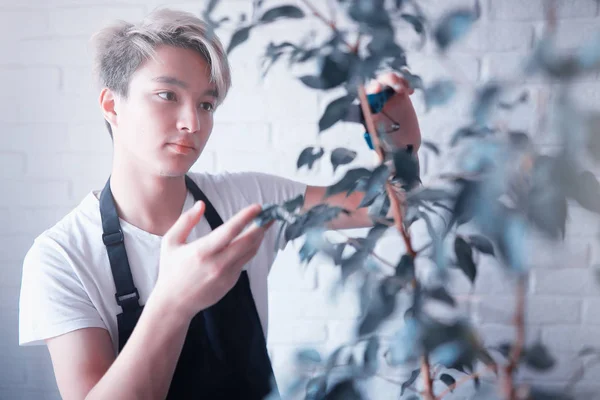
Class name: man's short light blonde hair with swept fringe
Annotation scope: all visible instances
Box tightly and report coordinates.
[92,8,231,137]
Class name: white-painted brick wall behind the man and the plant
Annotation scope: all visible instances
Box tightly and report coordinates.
[0,0,600,399]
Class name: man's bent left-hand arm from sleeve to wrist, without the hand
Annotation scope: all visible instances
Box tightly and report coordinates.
[46,290,190,400]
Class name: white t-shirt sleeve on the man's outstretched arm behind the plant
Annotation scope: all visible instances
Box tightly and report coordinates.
[225,172,307,249]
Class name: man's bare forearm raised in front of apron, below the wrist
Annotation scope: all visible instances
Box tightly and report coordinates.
[86,296,191,400]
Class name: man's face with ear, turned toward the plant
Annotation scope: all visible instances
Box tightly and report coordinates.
[115,46,217,176]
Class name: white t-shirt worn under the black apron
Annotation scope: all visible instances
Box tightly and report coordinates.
[19,172,306,354]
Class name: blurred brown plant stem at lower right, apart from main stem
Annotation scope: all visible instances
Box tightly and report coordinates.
[504,277,527,400]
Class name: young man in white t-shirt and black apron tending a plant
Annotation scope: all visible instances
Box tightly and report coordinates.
[19,6,420,400]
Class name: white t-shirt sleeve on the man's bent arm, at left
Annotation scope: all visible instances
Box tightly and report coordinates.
[19,236,106,346]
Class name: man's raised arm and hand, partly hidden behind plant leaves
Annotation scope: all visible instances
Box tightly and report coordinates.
[304,73,421,229]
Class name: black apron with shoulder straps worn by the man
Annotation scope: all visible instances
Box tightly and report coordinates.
[100,176,277,400]
